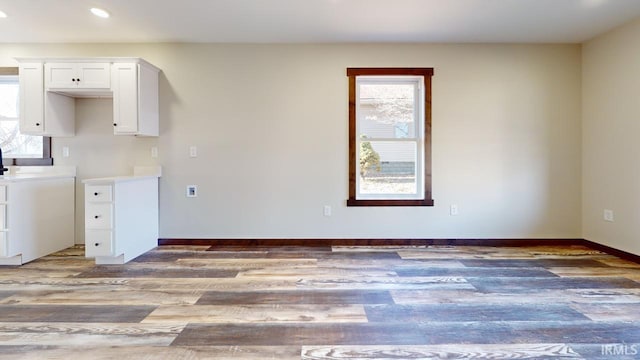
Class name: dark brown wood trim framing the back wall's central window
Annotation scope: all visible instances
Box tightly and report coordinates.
[347,68,434,206]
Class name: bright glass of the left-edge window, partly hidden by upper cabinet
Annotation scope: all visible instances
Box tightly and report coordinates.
[0,76,43,158]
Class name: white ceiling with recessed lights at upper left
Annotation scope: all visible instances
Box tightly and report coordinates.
[0,0,640,43]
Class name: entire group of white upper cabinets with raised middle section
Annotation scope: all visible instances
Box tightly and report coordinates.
[17,58,160,136]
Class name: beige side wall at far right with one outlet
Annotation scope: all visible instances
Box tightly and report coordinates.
[582,20,640,254]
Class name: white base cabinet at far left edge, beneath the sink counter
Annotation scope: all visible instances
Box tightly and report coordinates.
[0,170,75,265]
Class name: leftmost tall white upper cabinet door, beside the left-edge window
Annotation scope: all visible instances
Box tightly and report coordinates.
[19,63,44,135]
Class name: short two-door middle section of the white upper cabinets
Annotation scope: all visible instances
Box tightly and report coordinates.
[44,62,111,90]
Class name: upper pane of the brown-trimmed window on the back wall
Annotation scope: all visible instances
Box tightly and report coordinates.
[358,83,416,139]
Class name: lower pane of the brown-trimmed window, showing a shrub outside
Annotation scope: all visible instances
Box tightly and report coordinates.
[358,141,417,195]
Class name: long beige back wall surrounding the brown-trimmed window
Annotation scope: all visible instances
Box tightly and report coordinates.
[0,44,582,242]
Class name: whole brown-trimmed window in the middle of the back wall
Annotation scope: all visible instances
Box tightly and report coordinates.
[347,68,433,206]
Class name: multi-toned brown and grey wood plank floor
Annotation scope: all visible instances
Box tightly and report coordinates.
[0,246,640,360]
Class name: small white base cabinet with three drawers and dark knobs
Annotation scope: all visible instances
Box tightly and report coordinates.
[84,176,158,264]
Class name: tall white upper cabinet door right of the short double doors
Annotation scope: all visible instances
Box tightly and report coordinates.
[111,63,138,135]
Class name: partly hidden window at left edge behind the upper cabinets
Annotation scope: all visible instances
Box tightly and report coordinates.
[0,67,53,166]
